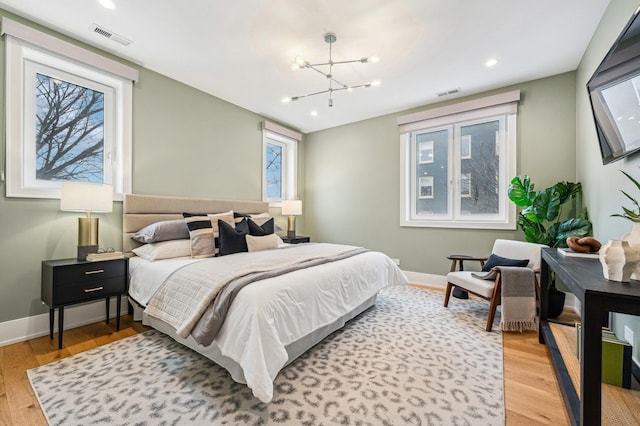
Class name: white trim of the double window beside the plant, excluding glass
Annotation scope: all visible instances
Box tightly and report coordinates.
[397,91,520,230]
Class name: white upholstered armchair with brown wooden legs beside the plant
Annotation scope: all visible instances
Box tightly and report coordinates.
[444,239,546,331]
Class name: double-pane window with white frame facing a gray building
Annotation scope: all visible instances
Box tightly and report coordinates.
[398,92,520,229]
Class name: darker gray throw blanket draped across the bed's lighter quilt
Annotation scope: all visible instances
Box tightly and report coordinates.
[191,248,367,346]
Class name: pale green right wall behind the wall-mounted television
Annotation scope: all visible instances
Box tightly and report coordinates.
[576,0,640,362]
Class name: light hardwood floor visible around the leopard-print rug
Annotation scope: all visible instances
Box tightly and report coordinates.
[0,302,569,426]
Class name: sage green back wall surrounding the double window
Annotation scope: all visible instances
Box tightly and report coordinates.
[304,72,576,275]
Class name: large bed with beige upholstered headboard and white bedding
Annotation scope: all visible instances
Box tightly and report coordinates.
[123,194,407,403]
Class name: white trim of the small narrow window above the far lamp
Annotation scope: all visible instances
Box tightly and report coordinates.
[262,120,302,207]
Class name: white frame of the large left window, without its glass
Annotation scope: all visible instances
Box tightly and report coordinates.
[2,17,138,200]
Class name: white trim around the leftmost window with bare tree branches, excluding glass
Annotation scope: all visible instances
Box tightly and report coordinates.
[1,17,138,200]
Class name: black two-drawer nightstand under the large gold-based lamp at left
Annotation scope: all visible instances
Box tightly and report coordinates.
[41,259,128,349]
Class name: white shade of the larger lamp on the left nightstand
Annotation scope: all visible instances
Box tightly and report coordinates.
[60,182,113,213]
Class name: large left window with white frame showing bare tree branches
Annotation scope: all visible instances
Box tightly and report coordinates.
[2,18,137,199]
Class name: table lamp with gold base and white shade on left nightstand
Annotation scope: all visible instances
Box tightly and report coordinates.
[60,182,113,260]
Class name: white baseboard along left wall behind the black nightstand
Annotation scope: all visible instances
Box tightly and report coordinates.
[0,297,127,346]
